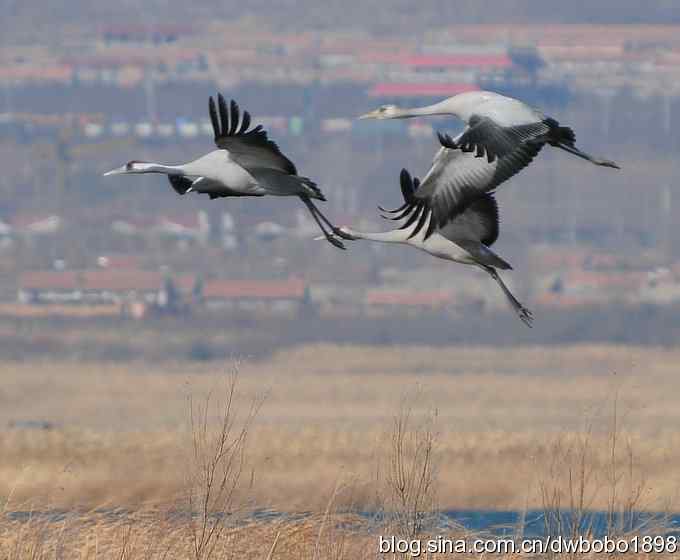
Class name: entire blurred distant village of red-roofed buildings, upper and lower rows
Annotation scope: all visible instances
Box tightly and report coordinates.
[0,22,680,319]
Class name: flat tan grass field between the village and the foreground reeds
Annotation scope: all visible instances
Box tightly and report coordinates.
[0,346,680,510]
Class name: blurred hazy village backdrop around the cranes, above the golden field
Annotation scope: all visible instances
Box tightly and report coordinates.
[0,0,680,360]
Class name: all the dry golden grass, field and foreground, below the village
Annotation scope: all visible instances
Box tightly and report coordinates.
[0,346,680,560]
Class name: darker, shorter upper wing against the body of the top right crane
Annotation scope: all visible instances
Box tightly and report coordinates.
[442,115,556,163]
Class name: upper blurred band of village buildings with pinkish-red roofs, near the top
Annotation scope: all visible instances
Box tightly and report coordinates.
[0,23,680,140]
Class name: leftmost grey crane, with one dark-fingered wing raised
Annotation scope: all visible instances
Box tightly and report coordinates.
[104,94,345,249]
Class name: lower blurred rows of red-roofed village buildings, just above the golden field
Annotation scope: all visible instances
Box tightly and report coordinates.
[0,212,680,319]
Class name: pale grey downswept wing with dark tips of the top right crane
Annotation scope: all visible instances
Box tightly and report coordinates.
[415,135,544,227]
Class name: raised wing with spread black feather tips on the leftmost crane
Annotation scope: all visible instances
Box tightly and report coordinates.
[209,93,297,175]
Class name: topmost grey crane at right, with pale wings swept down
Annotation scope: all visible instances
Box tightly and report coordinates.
[359,91,619,226]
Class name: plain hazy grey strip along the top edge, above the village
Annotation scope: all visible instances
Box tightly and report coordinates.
[5,0,680,41]
